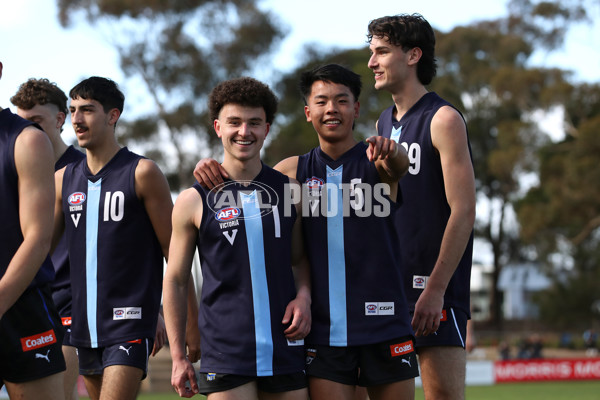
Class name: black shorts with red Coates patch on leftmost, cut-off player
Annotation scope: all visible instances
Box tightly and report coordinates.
[0,286,65,386]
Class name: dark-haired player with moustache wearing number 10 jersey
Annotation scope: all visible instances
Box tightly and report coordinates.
[54,77,173,399]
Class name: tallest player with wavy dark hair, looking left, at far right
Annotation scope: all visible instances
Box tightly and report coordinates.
[368,14,475,400]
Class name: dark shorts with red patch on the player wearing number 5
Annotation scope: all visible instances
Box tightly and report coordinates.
[306,336,419,386]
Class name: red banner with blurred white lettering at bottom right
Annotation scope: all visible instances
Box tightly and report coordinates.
[494,358,600,383]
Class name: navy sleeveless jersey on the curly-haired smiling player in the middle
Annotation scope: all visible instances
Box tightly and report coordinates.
[194,165,304,376]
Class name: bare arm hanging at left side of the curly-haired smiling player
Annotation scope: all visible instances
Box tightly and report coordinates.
[163,189,202,397]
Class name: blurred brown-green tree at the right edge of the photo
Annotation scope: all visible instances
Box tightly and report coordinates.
[517,84,600,329]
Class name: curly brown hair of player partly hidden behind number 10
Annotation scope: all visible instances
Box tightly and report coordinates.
[10,78,69,115]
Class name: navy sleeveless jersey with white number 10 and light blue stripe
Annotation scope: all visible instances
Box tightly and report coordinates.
[62,148,163,348]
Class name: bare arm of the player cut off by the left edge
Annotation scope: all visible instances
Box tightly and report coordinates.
[0,127,54,318]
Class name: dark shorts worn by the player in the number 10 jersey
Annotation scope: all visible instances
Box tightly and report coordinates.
[77,338,154,379]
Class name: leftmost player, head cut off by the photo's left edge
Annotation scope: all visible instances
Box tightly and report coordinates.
[0,59,65,400]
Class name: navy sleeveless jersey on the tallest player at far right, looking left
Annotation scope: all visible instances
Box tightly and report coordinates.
[377,92,473,315]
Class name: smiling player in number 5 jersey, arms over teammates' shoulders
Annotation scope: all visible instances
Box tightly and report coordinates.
[195,64,418,400]
